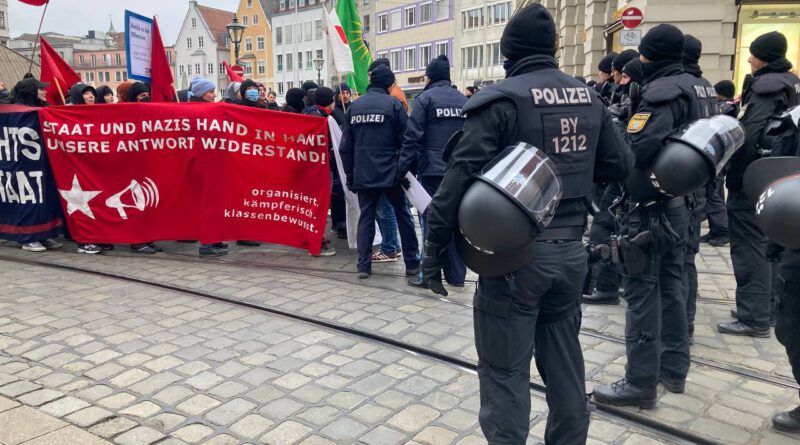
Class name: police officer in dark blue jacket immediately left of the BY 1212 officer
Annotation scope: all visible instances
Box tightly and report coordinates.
[398,55,467,287]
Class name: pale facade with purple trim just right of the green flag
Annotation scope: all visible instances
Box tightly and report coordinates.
[362,0,461,99]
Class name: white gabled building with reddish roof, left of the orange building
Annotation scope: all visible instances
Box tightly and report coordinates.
[175,0,233,96]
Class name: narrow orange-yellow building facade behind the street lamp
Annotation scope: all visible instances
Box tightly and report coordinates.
[231,0,275,90]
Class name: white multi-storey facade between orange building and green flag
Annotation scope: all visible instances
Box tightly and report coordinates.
[271,0,333,101]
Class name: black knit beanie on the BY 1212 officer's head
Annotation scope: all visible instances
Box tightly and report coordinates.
[500,3,556,62]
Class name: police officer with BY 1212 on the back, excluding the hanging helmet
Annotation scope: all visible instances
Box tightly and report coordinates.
[423,4,630,444]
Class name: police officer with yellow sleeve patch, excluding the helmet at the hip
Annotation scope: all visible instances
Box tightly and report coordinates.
[594,24,712,408]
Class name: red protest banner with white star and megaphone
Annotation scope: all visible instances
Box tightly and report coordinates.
[39,103,330,253]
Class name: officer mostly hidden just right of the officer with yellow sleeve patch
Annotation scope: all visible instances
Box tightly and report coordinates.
[682,34,719,344]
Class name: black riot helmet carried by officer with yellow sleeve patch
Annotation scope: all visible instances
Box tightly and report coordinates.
[625,115,744,202]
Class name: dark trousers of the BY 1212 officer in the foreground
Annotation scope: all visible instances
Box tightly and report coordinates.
[473,241,589,445]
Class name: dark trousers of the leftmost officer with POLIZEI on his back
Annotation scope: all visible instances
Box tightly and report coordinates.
[357,186,419,272]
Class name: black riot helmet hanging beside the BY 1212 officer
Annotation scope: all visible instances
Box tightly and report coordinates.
[456,143,562,277]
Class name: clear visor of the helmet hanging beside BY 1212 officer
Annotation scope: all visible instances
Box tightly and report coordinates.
[480,142,562,230]
